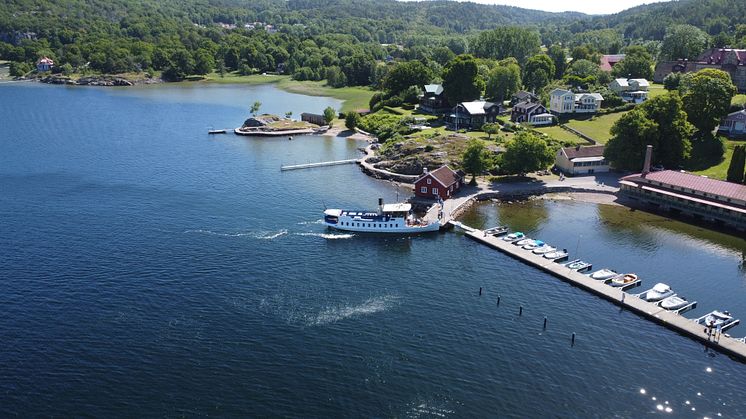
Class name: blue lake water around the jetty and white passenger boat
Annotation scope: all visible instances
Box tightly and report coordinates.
[0,84,746,418]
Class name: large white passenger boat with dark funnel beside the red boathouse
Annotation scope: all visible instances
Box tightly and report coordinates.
[324,199,440,234]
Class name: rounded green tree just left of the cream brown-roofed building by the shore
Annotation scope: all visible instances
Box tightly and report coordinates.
[500,131,554,173]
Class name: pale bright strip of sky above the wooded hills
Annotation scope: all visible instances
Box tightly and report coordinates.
[436,0,663,14]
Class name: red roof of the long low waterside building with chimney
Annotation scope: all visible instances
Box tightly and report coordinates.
[623,170,746,201]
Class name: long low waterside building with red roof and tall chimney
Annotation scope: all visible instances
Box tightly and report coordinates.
[619,149,746,231]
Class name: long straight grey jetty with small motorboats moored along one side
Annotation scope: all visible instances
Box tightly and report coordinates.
[449,221,746,362]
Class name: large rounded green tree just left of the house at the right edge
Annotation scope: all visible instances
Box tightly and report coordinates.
[679,68,736,133]
